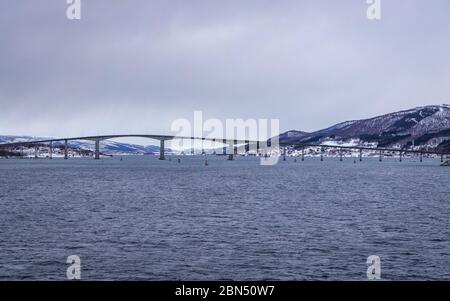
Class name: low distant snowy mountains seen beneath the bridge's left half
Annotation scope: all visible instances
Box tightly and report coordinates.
[0,136,172,155]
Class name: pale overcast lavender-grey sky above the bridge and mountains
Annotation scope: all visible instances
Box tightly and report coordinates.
[0,0,450,143]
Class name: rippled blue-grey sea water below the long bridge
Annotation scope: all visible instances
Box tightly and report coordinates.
[0,156,450,280]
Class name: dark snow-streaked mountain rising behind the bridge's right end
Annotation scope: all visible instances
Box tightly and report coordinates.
[280,104,450,149]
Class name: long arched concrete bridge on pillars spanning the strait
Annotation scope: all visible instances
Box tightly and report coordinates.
[0,134,450,162]
